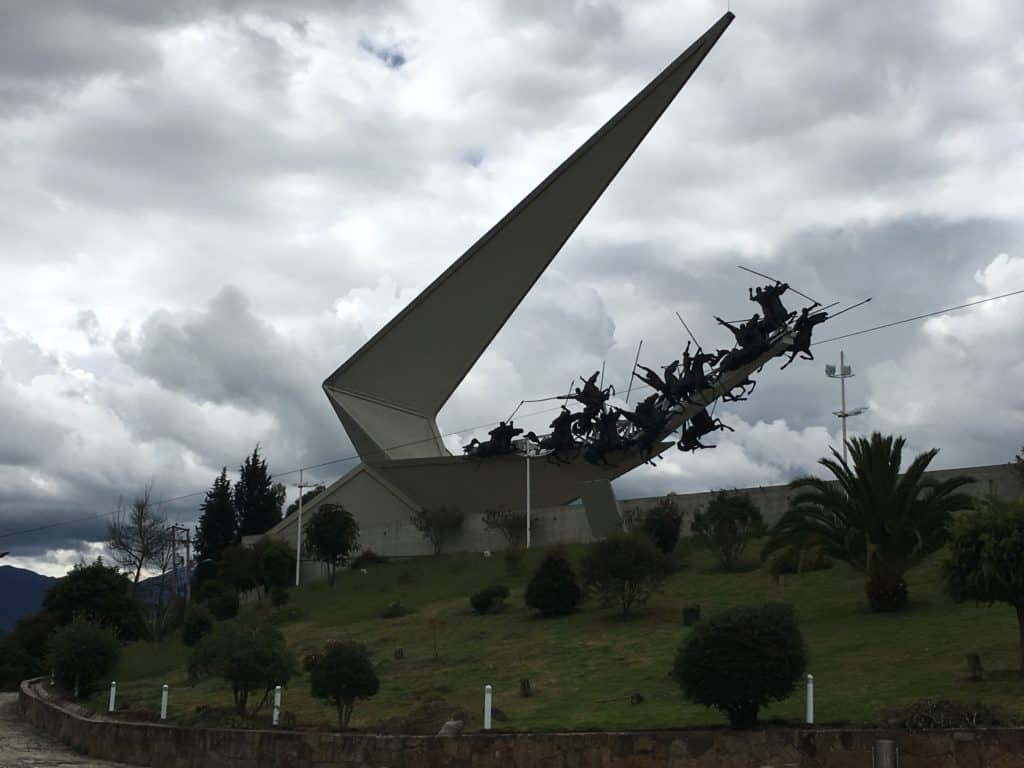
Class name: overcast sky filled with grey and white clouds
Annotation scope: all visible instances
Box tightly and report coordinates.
[0,0,1024,573]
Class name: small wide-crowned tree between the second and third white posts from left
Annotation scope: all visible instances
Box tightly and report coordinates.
[188,622,296,716]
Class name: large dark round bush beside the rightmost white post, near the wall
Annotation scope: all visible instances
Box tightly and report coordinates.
[672,605,807,728]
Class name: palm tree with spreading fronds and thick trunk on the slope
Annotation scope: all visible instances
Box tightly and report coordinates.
[765,432,974,610]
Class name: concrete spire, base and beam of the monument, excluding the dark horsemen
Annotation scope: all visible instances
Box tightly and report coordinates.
[269,13,733,555]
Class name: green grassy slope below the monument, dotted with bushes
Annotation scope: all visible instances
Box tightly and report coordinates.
[92,546,1024,732]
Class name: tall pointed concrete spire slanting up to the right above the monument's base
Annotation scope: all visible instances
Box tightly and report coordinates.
[324,13,733,464]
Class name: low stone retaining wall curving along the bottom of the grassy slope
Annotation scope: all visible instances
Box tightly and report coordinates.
[18,680,1024,768]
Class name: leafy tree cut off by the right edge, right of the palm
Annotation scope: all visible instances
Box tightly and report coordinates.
[942,498,1024,673]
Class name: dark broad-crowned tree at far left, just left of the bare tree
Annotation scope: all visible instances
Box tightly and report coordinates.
[43,557,145,640]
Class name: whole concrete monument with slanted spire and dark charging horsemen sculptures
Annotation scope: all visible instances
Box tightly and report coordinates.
[262,13,823,557]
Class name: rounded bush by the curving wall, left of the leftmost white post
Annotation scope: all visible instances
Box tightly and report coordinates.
[46,615,120,696]
